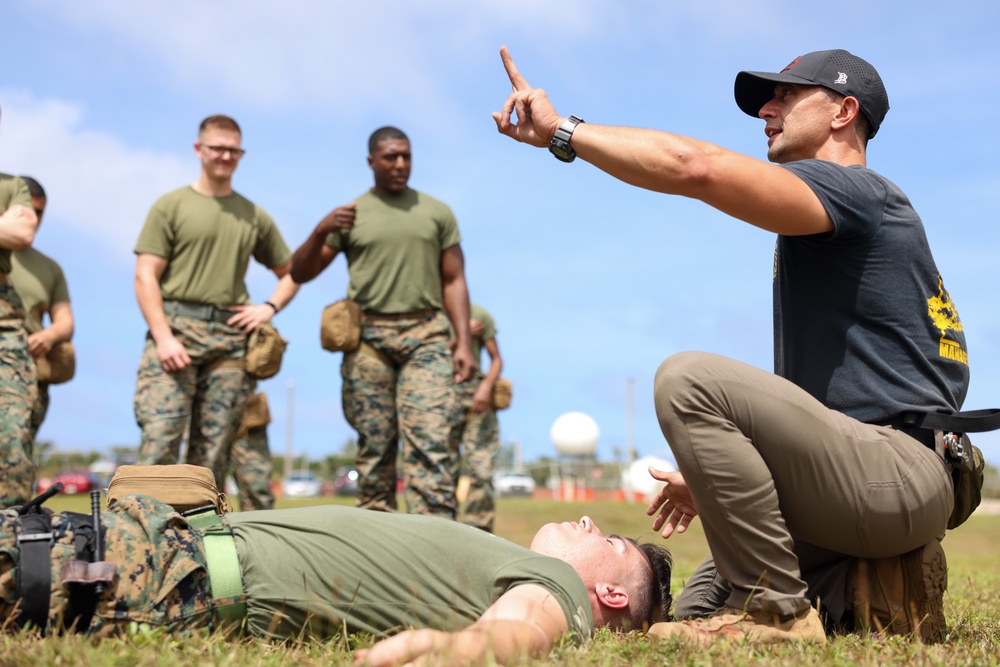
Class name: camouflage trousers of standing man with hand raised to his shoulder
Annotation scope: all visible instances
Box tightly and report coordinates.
[341,311,457,519]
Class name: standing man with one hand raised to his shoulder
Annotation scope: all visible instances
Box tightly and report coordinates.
[291,127,475,519]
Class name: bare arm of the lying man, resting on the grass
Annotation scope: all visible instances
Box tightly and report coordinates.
[354,584,569,667]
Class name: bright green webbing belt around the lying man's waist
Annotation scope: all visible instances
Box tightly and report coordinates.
[187,511,246,625]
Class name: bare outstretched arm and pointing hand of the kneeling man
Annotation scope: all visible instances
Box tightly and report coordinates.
[493,47,833,235]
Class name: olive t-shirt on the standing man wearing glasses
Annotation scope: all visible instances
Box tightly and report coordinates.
[135,186,292,306]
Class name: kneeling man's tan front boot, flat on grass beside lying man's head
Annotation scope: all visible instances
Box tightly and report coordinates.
[646,607,826,644]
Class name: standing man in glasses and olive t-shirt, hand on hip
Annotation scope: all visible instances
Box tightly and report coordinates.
[135,116,298,488]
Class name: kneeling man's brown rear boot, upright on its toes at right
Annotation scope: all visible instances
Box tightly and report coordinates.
[847,540,948,643]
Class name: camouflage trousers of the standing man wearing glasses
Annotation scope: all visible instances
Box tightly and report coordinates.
[134,317,250,489]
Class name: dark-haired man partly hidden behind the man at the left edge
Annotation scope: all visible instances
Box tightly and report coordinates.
[10,176,73,448]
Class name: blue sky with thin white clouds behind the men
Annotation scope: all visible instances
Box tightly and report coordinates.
[0,0,1000,464]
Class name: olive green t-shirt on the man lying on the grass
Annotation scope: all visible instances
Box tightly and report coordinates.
[229,505,594,641]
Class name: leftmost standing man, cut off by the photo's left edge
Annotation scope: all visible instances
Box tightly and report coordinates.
[0,167,38,507]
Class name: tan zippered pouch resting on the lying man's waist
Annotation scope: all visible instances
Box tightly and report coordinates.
[108,463,229,514]
